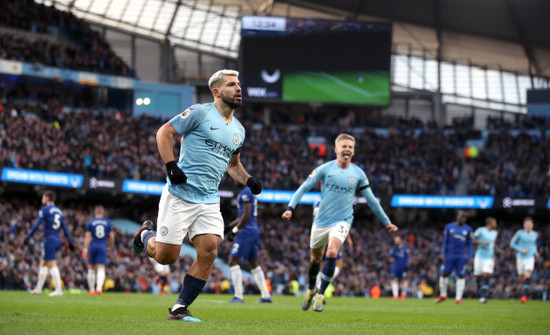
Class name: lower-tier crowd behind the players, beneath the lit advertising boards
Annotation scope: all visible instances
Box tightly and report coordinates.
[0,197,550,299]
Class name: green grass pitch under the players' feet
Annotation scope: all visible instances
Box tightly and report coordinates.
[0,291,550,335]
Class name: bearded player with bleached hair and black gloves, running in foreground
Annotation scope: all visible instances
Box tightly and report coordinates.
[133,70,262,322]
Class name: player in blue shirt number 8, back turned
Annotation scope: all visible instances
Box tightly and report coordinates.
[84,205,115,295]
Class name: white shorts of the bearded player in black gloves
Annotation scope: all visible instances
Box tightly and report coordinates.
[156,185,223,245]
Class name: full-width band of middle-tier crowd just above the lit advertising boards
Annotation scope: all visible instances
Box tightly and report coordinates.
[4,90,550,197]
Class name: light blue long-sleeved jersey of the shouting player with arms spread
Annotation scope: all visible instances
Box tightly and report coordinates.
[288,160,390,227]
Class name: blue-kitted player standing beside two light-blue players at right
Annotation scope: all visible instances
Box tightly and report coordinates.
[436,211,474,304]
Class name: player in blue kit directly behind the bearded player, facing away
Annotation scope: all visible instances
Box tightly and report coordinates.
[227,185,271,303]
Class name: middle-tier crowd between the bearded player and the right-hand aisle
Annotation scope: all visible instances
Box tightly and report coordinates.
[240,107,461,195]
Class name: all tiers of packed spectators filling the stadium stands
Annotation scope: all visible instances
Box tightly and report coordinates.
[0,0,550,306]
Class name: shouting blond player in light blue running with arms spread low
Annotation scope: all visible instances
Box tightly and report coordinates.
[282,134,397,312]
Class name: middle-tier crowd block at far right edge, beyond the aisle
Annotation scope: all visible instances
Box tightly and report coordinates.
[468,116,550,198]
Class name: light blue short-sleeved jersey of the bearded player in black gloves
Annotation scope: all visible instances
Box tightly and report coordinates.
[166,102,245,204]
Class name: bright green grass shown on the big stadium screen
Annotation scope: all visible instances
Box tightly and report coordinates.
[283,71,390,105]
